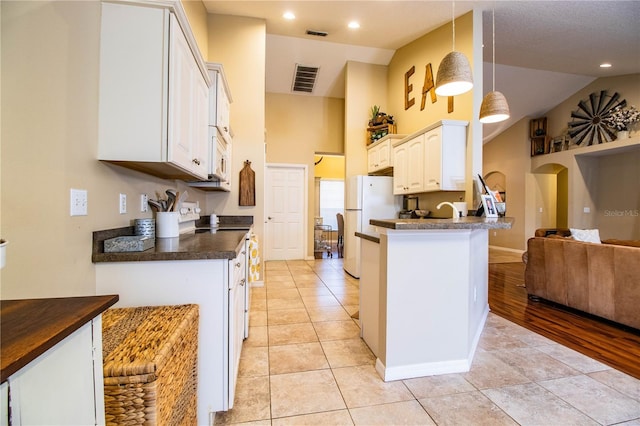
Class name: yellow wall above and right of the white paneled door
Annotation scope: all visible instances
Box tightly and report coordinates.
[266,93,344,256]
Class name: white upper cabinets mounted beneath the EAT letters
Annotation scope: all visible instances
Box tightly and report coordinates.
[393,120,468,195]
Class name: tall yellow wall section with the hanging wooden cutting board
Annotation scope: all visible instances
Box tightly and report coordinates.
[206,14,266,255]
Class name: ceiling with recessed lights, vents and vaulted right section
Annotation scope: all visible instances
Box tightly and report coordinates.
[203,0,640,142]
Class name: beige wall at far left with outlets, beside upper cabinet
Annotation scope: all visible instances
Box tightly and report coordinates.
[0,1,205,299]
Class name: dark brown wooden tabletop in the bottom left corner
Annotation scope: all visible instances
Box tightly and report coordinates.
[0,295,119,383]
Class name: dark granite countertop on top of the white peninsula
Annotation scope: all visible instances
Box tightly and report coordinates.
[369,216,514,231]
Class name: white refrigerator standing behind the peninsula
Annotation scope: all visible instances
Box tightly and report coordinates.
[343,176,402,278]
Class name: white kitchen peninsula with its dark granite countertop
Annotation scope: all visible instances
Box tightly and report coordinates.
[356,217,513,381]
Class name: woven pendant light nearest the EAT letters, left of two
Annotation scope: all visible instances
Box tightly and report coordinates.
[436,2,473,96]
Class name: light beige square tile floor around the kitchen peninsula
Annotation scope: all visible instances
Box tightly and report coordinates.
[215,258,640,426]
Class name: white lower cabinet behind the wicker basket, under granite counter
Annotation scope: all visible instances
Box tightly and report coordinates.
[96,236,248,424]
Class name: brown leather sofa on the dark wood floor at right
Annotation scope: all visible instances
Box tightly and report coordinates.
[523,229,640,329]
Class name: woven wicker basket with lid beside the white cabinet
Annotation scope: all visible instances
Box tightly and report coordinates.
[102,305,198,425]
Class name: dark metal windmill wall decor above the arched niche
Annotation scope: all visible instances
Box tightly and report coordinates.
[568,90,627,146]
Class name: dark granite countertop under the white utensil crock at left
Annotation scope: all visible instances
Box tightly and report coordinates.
[91,226,247,263]
